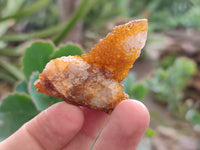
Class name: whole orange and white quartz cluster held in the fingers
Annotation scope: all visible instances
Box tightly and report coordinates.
[34,19,148,113]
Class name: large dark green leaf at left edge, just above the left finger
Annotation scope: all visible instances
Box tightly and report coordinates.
[0,94,39,141]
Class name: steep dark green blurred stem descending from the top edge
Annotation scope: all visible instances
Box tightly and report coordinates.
[54,0,90,45]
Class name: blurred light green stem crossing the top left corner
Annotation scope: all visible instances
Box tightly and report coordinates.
[0,0,51,22]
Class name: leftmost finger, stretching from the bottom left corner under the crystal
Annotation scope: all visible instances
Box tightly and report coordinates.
[0,102,84,150]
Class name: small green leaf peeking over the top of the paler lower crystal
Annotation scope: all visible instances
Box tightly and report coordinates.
[51,44,83,59]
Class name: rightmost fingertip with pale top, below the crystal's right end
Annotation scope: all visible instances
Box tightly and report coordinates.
[94,100,149,150]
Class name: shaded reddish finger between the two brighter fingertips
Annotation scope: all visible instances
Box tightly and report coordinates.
[64,108,109,150]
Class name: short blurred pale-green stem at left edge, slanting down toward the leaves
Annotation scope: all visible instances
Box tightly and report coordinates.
[0,59,24,80]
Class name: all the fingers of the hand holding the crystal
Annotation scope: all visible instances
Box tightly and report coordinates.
[0,100,149,150]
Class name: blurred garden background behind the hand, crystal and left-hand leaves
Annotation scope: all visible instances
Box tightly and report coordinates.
[0,0,200,150]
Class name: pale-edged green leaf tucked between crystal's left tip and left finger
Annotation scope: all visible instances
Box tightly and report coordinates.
[29,72,62,111]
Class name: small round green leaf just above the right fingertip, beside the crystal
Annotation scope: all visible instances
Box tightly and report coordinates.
[131,84,147,100]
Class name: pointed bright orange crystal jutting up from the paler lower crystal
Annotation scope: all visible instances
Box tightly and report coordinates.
[81,19,147,82]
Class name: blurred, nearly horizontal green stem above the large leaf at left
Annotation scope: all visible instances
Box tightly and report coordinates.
[0,23,65,42]
